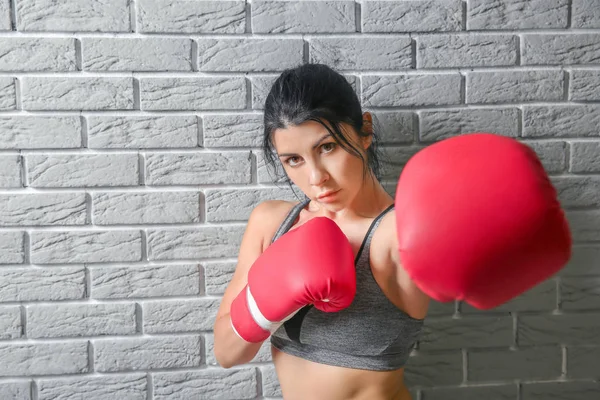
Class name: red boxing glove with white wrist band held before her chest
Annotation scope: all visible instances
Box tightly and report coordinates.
[230,217,356,343]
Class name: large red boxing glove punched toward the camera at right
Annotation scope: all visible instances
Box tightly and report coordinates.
[395,133,571,309]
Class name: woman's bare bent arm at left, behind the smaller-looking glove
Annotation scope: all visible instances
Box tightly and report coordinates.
[213,201,273,368]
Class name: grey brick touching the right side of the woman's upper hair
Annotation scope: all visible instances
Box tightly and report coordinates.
[362,74,461,107]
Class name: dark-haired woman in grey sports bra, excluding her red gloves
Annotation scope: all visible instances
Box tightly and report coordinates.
[214,64,429,400]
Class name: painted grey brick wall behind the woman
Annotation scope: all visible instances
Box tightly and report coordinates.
[0,0,600,400]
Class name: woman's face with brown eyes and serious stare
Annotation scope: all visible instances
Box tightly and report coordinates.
[273,121,371,211]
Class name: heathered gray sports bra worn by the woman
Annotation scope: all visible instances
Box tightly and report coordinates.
[271,200,424,371]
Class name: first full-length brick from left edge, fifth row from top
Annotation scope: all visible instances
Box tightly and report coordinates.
[26,153,139,187]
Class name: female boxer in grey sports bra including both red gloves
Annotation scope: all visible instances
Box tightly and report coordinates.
[214,65,571,400]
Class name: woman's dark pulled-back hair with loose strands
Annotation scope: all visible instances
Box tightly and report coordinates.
[262,64,380,188]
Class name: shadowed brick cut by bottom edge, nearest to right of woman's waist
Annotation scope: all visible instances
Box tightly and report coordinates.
[421,384,519,400]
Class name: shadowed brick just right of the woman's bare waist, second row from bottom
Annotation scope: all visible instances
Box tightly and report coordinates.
[405,351,463,387]
